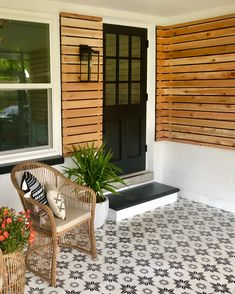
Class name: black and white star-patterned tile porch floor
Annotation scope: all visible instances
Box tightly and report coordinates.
[25,198,235,294]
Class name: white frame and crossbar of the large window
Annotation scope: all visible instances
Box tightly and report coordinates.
[0,9,62,165]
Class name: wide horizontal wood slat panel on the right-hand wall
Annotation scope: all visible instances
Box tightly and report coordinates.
[156,14,235,149]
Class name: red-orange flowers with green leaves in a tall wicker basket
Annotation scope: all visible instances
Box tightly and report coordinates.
[0,207,35,294]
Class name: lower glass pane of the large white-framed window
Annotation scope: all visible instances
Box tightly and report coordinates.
[0,90,49,151]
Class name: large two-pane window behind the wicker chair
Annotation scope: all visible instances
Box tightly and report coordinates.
[0,13,61,163]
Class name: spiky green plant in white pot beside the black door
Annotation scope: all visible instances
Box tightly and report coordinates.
[64,143,125,228]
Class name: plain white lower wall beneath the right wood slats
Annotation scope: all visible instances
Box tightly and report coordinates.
[154,142,235,212]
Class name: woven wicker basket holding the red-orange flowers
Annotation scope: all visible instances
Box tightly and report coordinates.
[0,252,25,294]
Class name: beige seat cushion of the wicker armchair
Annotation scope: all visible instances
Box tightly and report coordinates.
[46,207,91,233]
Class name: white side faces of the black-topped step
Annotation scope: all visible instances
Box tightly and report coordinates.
[108,193,178,221]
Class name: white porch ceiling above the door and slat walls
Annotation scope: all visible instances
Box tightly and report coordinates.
[56,0,235,17]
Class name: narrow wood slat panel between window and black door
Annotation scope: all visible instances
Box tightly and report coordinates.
[60,13,103,156]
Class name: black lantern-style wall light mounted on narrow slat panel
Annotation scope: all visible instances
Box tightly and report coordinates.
[79,45,100,82]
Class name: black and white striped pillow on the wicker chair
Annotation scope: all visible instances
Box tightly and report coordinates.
[21,171,48,205]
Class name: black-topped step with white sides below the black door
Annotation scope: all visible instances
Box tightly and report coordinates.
[107,182,179,221]
